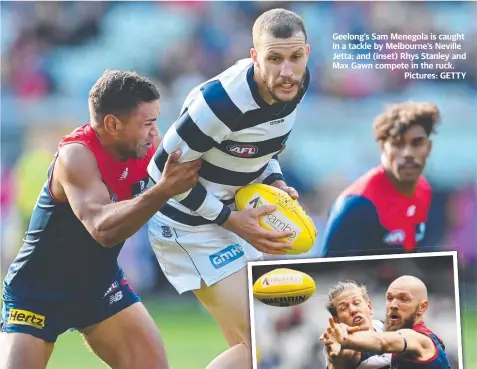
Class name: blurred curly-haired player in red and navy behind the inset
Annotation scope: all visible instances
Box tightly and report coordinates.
[322,101,440,257]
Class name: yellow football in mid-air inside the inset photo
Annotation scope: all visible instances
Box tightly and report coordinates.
[253,268,316,306]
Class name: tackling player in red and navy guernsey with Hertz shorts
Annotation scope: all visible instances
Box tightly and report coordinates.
[0,71,200,369]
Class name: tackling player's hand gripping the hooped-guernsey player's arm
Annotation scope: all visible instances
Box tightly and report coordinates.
[160,150,202,197]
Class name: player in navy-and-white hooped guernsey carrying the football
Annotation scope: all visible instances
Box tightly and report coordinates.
[149,9,310,369]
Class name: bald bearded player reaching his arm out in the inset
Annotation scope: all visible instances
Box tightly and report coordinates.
[324,276,451,369]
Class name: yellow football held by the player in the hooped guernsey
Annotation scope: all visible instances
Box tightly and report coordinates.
[235,184,317,255]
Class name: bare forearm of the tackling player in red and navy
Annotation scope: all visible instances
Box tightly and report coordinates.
[90,183,170,247]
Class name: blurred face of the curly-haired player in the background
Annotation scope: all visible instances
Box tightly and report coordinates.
[382,125,432,182]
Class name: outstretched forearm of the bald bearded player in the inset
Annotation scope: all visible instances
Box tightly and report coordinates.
[341,331,404,353]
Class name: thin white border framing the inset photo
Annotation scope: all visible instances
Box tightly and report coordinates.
[247,251,464,369]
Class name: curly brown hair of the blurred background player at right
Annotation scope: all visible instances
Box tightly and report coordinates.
[373,101,440,142]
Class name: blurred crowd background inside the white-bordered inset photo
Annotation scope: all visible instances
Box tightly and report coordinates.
[253,256,462,369]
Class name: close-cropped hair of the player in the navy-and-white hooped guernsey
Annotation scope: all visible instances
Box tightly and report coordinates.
[252,8,307,48]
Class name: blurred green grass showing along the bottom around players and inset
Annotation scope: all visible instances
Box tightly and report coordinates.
[35,301,477,369]
